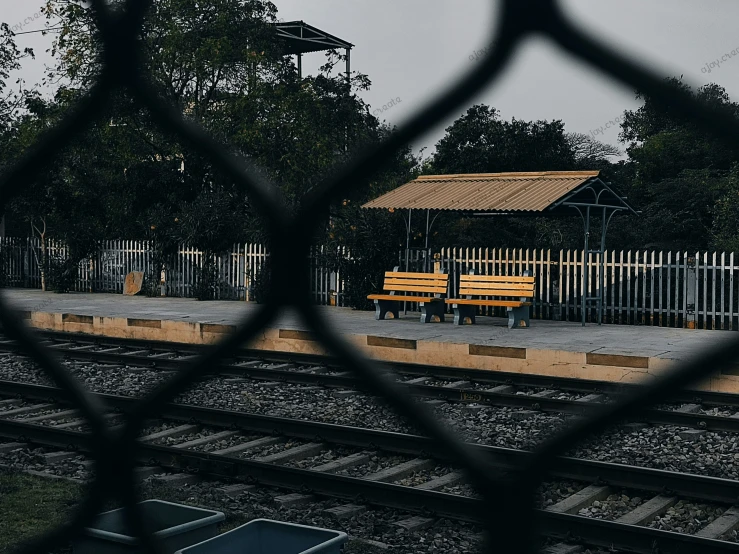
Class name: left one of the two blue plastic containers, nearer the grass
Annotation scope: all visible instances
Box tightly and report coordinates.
[74,500,226,554]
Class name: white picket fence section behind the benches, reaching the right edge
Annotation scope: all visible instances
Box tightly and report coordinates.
[434,248,739,330]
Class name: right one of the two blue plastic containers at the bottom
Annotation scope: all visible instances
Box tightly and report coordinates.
[177,519,349,554]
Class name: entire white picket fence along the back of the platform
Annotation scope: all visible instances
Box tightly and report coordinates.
[5,238,739,330]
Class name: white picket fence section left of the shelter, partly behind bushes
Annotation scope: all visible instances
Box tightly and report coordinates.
[0,238,346,305]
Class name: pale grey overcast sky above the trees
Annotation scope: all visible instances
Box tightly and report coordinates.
[0,0,739,157]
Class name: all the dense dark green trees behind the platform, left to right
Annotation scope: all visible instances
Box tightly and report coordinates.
[0,5,739,307]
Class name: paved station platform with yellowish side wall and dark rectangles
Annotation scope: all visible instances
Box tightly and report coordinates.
[2,289,739,393]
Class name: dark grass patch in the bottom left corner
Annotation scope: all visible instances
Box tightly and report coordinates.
[0,472,82,554]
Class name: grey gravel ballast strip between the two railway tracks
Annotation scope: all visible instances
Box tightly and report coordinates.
[0,357,739,488]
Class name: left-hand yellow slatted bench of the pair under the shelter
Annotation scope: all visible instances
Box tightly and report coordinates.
[367,267,449,323]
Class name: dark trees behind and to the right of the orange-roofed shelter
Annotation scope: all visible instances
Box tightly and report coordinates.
[419,79,739,251]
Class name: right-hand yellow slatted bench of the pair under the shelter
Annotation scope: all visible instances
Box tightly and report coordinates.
[446,275,534,329]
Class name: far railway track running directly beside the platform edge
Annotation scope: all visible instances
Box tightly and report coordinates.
[0,332,739,432]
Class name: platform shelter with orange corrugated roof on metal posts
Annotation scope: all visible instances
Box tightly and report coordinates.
[362,171,637,325]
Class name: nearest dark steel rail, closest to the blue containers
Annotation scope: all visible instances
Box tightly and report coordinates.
[0,420,739,554]
